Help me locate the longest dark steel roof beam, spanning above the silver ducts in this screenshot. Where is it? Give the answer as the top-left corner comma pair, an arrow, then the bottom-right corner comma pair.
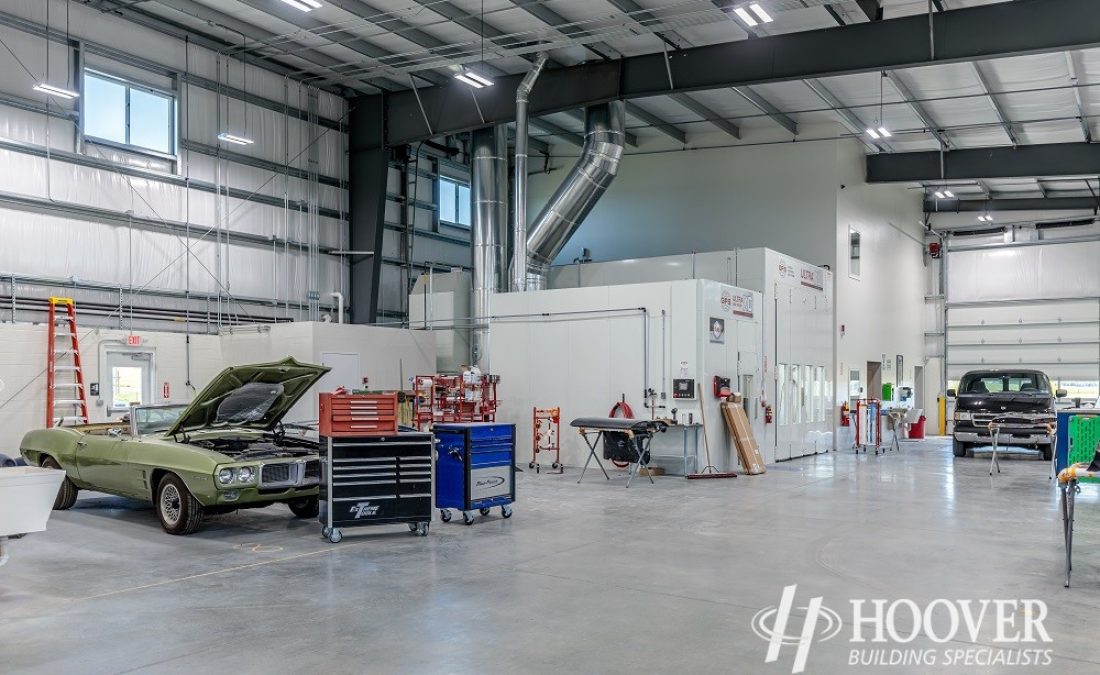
378,0 -> 1100,144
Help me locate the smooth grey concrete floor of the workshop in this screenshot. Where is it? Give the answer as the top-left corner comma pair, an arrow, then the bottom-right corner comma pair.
0,440 -> 1100,675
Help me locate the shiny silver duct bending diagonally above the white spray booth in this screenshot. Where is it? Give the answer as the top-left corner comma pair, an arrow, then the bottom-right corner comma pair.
525,101 -> 626,290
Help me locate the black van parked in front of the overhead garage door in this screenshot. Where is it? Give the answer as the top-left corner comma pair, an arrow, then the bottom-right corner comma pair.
947,369 -> 1066,461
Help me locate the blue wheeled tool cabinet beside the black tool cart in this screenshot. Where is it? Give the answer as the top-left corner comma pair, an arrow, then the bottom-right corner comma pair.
432,422 -> 516,525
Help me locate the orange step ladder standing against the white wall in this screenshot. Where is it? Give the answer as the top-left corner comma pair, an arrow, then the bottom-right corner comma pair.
46,297 -> 88,429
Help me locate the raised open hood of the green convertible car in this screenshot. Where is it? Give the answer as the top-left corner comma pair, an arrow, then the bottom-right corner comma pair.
165,357 -> 330,435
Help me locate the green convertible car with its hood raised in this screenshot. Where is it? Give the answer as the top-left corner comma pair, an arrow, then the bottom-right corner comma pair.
20,358 -> 329,534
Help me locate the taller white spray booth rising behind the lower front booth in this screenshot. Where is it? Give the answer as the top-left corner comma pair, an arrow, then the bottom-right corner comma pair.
549,248 -> 836,462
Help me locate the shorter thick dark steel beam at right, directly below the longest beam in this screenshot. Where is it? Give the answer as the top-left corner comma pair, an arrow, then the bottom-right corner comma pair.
867,143 -> 1100,182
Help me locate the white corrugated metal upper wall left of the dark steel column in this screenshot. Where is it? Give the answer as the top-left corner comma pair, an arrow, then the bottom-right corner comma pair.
0,0 -> 348,328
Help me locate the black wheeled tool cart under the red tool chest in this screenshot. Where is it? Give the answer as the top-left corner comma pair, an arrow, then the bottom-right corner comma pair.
319,432 -> 433,543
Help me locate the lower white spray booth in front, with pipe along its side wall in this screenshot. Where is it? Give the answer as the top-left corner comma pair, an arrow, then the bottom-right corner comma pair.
488,279 -> 762,472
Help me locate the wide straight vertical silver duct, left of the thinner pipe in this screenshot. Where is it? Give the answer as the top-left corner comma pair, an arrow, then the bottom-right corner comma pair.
470,124 -> 508,373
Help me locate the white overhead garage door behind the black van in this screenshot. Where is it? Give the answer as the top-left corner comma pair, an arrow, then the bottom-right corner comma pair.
946,237 -> 1100,400
